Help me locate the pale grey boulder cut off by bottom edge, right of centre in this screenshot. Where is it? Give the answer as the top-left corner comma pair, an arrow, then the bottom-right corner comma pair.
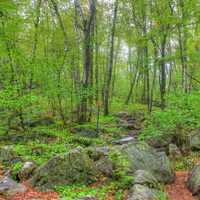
127,184 -> 158,200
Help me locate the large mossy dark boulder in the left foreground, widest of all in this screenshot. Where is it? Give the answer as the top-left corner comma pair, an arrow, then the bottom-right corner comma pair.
29,148 -> 99,190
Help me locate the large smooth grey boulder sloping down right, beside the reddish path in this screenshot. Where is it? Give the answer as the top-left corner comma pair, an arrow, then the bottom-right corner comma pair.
121,142 -> 175,183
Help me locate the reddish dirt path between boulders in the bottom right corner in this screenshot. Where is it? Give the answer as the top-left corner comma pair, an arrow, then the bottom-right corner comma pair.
166,172 -> 197,200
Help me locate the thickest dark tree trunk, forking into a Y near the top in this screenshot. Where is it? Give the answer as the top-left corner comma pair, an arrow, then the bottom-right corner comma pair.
75,0 -> 96,122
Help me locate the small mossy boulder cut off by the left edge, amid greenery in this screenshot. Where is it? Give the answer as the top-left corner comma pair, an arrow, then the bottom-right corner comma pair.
0,145 -> 20,163
